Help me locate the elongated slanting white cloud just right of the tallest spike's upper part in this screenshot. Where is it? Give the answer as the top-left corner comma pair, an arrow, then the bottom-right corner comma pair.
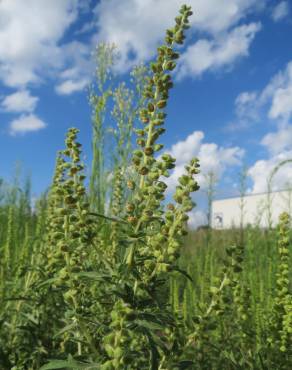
178,23 -> 261,77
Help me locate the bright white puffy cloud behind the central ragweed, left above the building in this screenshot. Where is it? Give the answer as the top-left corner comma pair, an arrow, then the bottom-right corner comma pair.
166,131 -> 244,191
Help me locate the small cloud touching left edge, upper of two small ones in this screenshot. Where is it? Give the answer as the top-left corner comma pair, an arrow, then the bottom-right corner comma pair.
1,90 -> 39,112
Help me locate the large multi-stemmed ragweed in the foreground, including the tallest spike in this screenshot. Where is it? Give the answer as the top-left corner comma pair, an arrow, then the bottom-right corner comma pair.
37,6 -> 198,369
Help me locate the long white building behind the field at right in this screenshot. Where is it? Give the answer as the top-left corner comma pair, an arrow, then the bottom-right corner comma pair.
212,190 -> 292,229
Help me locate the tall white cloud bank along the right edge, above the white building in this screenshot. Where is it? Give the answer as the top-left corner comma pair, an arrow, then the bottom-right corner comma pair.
234,61 -> 292,193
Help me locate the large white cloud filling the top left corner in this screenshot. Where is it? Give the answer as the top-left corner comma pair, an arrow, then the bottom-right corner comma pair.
0,0 -> 78,87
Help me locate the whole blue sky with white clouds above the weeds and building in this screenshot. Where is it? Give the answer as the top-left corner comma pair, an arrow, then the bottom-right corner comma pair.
0,0 -> 292,223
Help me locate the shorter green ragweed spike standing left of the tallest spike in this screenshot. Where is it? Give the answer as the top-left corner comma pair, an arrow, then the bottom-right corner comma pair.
45,129 -> 99,355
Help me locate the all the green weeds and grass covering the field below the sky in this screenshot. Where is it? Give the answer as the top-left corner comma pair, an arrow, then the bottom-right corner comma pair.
0,6 -> 292,370
